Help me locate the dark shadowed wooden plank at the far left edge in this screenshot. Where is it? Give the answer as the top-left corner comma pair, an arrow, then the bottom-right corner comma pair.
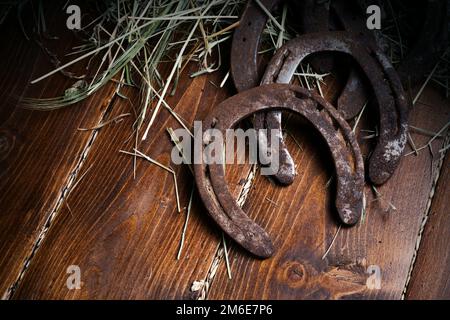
0,6 -> 118,298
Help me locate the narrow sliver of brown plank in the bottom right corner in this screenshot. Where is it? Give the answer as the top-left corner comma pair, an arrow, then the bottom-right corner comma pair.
406,153 -> 450,300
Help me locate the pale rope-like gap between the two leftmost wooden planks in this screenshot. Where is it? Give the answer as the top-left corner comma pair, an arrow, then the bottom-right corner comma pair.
2,89 -> 117,300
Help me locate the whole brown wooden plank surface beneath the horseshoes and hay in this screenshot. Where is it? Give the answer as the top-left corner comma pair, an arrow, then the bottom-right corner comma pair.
0,4 -> 450,299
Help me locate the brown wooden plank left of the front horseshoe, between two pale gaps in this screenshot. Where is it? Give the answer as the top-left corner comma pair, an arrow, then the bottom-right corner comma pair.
14,63 -> 255,299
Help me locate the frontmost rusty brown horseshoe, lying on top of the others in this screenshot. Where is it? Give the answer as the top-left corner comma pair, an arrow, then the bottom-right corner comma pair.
194,84 -> 364,258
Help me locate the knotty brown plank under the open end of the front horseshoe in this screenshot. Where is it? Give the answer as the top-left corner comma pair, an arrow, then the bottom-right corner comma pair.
208,89 -> 449,299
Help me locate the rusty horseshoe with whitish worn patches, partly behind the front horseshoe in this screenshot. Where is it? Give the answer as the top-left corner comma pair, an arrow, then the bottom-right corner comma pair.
255,31 -> 410,185
